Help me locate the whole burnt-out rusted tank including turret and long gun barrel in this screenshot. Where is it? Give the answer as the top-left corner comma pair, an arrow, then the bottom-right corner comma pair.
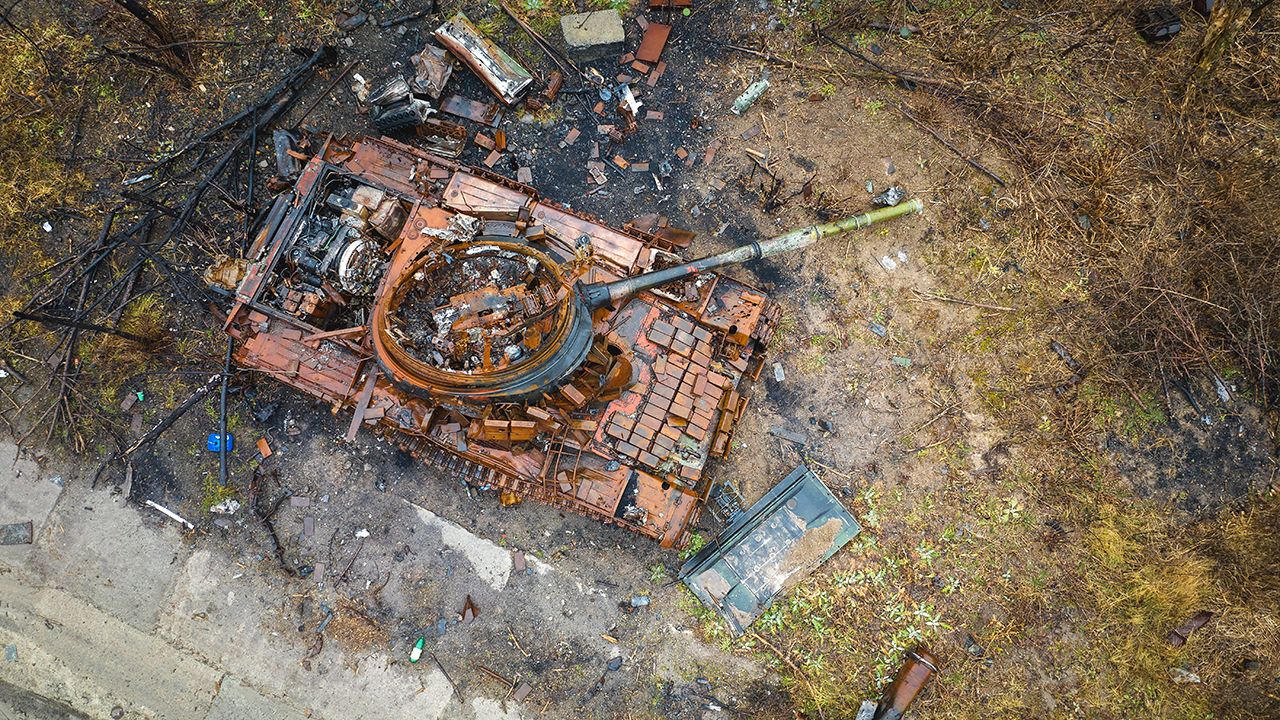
220,137 -> 922,547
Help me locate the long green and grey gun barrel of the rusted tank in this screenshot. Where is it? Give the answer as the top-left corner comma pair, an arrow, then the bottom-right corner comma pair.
581,199 -> 924,310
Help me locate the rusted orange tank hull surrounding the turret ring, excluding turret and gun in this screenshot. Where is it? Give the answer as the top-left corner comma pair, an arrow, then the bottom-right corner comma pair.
227,138 -> 778,547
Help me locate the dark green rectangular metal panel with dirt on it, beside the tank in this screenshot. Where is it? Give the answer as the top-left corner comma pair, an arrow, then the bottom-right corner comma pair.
680,465 -> 861,637
